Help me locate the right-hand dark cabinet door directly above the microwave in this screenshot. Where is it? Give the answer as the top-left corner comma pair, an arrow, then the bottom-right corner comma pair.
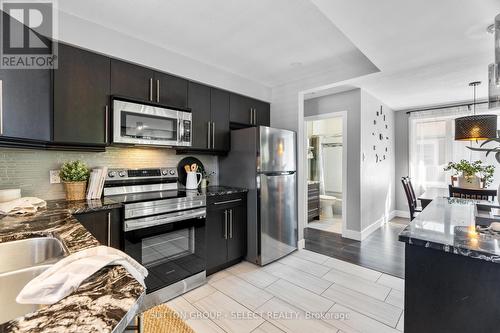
154,72 -> 188,108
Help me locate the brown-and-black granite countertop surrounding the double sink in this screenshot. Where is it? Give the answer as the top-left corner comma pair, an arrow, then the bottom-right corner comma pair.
0,199 -> 145,332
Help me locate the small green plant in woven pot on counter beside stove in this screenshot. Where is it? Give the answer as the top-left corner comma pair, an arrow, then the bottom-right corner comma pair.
59,160 -> 90,200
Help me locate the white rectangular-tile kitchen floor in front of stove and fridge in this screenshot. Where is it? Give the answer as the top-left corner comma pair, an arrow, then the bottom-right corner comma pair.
167,250 -> 404,333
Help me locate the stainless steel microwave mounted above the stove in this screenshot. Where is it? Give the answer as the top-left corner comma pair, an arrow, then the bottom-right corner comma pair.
113,98 -> 192,147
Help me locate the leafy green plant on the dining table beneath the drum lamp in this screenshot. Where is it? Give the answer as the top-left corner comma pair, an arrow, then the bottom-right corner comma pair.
444,160 -> 495,189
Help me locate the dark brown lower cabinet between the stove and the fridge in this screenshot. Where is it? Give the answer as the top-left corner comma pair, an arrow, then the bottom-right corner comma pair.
206,193 -> 247,275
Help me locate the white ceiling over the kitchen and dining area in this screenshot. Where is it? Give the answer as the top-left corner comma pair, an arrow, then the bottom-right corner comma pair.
59,0 -> 500,110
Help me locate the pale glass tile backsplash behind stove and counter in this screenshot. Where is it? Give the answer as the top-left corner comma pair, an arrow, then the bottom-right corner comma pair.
0,147 -> 219,199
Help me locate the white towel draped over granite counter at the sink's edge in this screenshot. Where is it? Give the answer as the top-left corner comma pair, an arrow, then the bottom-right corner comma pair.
16,246 -> 148,304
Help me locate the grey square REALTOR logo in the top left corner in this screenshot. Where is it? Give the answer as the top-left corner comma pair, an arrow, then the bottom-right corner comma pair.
0,0 -> 57,69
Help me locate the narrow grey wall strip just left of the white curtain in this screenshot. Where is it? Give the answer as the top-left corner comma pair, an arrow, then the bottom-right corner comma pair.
394,111 -> 410,211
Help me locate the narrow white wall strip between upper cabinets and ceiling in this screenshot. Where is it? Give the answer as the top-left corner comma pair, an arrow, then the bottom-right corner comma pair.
59,12 -> 271,101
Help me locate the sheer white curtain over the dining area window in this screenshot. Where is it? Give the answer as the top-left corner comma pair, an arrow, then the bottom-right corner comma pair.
409,104 -> 500,195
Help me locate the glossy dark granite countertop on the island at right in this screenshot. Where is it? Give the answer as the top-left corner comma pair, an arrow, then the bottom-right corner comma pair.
399,198 -> 500,263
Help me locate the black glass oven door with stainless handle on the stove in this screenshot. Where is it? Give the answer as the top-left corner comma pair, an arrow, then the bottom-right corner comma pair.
124,209 -> 206,294
